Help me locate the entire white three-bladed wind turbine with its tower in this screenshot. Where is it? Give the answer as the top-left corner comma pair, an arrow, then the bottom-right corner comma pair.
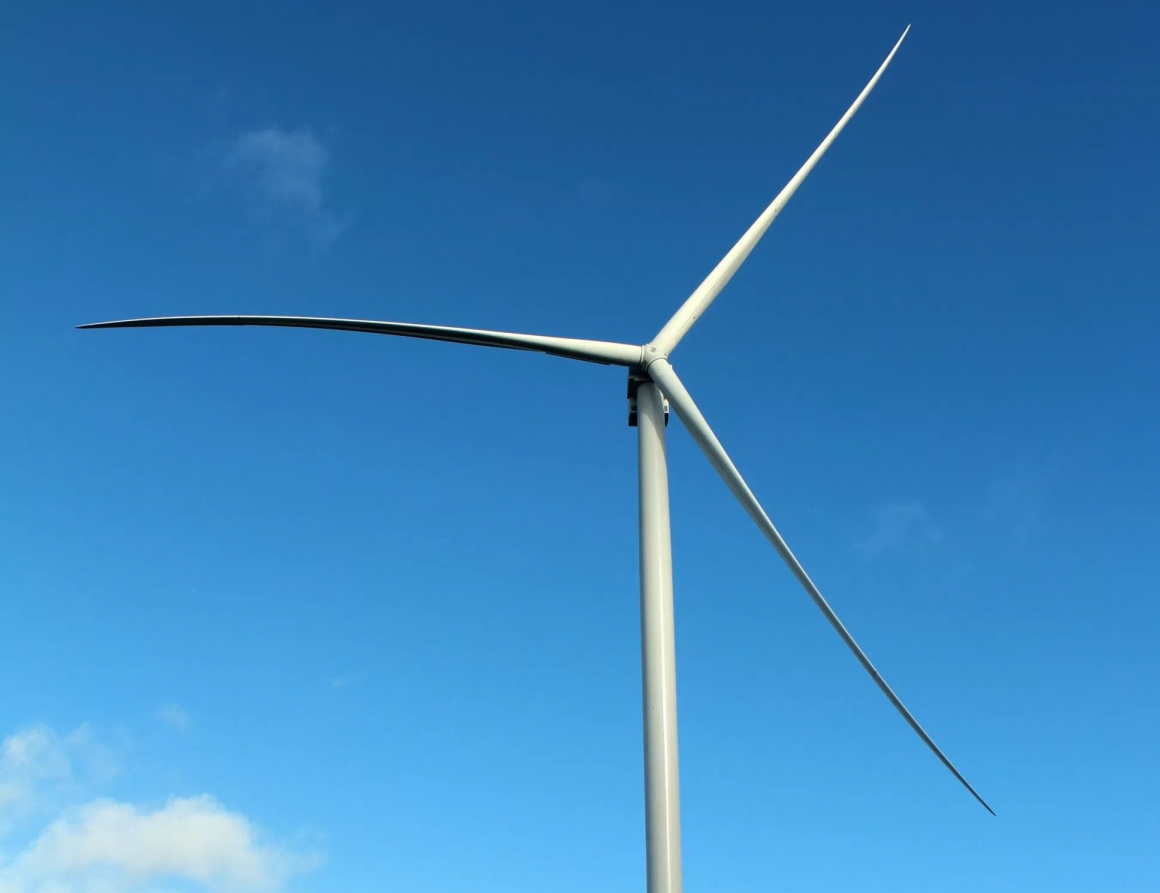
79,26 -> 994,893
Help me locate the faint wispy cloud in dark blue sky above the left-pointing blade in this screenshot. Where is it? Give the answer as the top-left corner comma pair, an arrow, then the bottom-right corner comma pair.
226,128 -> 342,244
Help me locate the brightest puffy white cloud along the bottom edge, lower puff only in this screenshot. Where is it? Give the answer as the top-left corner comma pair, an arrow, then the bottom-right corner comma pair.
0,796 -> 318,893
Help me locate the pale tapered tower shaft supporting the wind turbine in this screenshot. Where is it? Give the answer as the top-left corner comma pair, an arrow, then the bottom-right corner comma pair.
637,382 -> 681,893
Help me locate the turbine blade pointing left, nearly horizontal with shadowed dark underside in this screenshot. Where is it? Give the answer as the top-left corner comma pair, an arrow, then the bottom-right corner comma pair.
77,317 -> 640,366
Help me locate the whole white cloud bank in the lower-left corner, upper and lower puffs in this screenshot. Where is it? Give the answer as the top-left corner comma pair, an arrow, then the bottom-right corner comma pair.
0,726 -> 321,893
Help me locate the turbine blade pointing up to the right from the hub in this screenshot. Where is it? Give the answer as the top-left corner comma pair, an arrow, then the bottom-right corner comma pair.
652,26 -> 911,356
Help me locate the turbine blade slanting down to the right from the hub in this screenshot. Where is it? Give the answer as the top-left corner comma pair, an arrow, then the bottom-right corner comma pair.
648,360 -> 995,815
